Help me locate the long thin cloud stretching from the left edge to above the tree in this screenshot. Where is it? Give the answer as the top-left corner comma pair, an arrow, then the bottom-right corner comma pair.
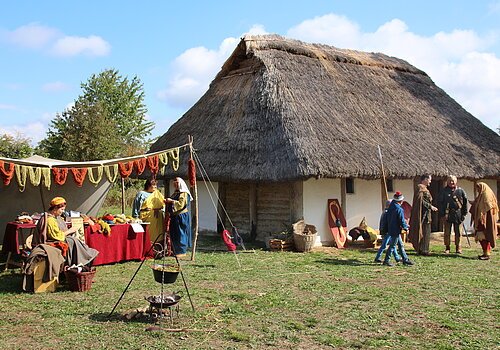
0,23 -> 111,57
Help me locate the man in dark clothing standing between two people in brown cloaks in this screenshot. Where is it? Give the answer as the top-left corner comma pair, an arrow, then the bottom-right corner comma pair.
438,175 -> 467,254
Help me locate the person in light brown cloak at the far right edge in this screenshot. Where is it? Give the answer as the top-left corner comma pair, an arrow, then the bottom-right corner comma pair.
470,182 -> 498,260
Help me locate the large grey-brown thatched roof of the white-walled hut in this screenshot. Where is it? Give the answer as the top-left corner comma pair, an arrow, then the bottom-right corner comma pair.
151,35 -> 500,181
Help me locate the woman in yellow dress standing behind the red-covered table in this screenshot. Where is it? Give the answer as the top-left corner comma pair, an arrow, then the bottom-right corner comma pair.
132,179 -> 165,242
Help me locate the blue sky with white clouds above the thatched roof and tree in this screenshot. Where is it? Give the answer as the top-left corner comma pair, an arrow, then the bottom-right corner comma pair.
0,0 -> 500,145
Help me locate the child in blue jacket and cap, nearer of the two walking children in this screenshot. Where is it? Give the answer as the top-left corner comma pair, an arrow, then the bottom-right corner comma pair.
377,191 -> 413,266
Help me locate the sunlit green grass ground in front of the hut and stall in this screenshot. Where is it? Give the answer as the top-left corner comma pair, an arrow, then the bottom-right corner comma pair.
0,235 -> 500,349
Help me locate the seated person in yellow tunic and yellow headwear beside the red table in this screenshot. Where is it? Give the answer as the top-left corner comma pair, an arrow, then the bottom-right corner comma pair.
46,197 -> 99,266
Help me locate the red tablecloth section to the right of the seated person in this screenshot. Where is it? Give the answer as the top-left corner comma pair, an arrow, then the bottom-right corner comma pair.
85,224 -> 152,265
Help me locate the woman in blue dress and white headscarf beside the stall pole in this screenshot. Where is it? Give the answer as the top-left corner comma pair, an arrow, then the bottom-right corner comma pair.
165,177 -> 192,257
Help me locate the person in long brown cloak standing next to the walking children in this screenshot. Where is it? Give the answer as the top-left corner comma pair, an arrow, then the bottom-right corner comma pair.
408,174 -> 438,255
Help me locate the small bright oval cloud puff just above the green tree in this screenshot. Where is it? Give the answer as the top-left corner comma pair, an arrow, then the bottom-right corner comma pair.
51,35 -> 111,57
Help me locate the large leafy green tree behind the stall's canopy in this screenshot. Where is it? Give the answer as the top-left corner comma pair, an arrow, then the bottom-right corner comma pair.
39,69 -> 154,161
